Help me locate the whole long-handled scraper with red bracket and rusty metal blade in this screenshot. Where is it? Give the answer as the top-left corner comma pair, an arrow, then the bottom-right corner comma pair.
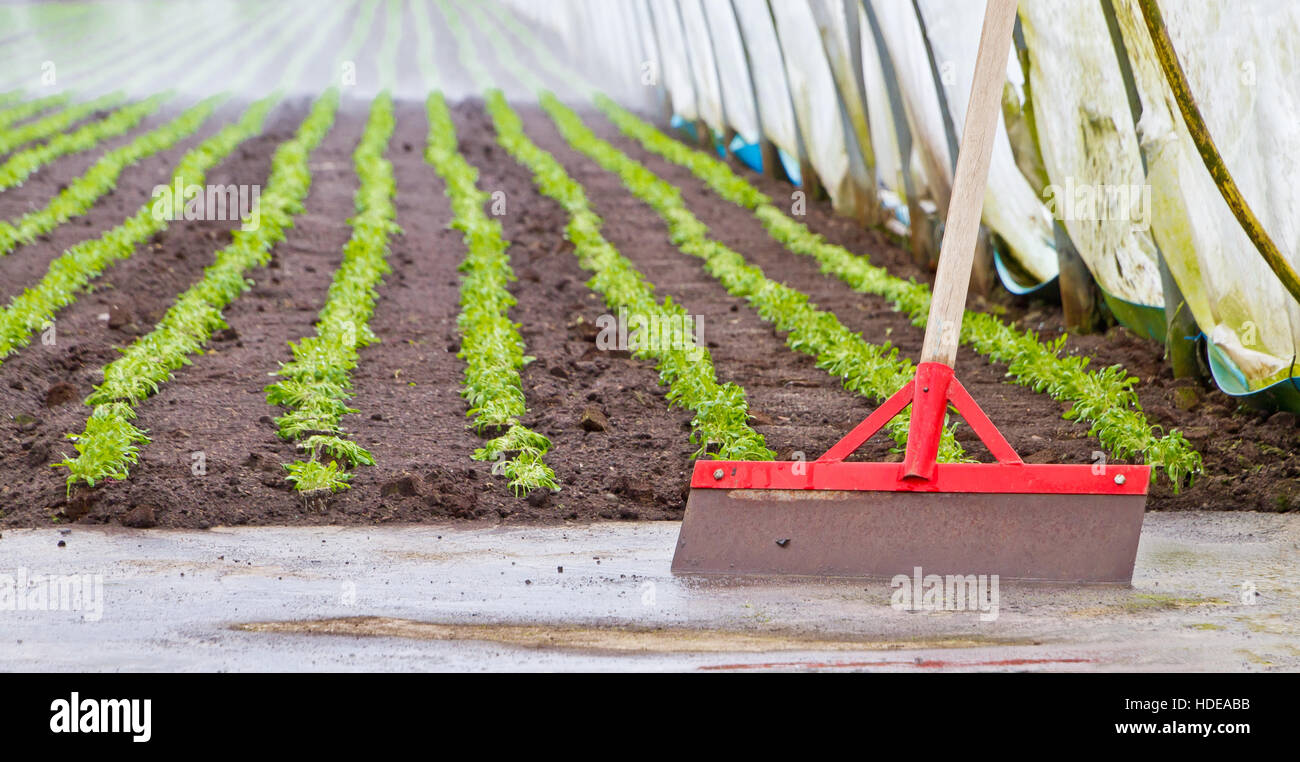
672,0 -> 1151,584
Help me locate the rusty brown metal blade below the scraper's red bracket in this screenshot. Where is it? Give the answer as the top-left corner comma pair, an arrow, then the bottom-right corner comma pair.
672,489 -> 1147,585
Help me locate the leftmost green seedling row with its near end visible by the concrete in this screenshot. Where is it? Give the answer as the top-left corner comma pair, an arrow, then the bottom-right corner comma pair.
55,90 -> 338,493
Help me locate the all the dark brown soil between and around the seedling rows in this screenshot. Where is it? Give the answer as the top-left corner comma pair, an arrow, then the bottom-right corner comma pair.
0,91 -> 1300,527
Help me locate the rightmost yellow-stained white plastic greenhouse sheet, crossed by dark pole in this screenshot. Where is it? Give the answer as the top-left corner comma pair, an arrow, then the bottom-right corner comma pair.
1117,0 -> 1300,390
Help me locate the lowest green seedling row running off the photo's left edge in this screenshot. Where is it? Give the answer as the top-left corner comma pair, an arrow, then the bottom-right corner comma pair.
0,95 -> 280,361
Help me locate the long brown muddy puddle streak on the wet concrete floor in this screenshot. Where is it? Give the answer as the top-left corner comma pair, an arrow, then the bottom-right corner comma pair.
234,616 -> 1039,653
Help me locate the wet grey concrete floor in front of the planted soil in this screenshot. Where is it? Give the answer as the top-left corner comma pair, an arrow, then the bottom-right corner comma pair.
0,512 -> 1300,671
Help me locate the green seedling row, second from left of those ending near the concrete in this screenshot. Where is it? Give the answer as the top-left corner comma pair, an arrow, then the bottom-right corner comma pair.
267,91 -> 400,497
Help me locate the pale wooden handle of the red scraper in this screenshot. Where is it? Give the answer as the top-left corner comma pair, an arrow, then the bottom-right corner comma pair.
913,0 -> 1015,368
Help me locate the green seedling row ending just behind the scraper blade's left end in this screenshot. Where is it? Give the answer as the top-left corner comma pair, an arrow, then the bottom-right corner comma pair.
486,90 -> 775,460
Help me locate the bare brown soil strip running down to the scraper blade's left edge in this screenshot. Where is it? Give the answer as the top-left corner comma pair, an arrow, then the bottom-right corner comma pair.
455,103 -> 696,519
